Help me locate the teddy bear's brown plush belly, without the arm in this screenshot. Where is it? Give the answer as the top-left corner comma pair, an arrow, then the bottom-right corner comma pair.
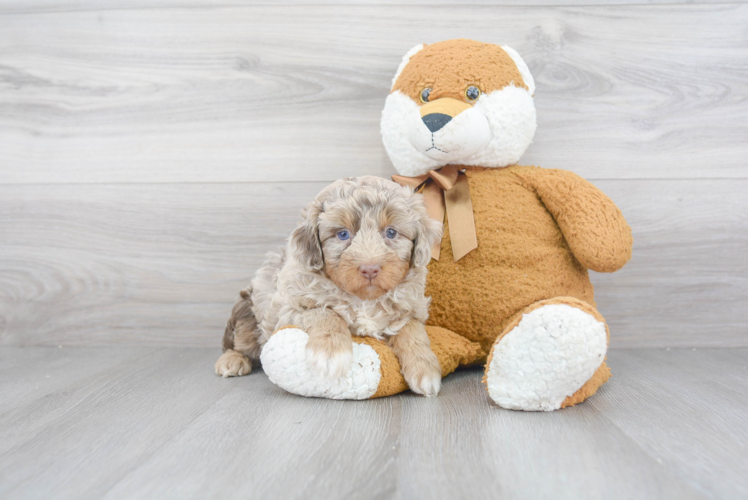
426,168 -> 594,352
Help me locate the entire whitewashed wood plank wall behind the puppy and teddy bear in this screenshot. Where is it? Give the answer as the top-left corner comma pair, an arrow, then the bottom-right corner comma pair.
0,0 -> 748,347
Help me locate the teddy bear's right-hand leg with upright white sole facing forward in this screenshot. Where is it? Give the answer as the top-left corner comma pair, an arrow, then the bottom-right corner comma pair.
483,297 -> 610,411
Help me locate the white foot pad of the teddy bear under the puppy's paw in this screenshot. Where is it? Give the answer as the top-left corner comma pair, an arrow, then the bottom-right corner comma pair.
260,328 -> 382,399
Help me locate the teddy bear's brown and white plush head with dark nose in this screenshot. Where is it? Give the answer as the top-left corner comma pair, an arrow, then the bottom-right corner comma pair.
381,39 -> 536,176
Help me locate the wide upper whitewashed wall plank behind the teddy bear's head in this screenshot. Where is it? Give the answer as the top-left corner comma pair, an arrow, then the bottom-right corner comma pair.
0,4 -> 748,184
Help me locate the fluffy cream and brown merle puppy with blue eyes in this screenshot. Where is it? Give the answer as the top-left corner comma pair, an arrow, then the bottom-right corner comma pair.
215,176 -> 442,396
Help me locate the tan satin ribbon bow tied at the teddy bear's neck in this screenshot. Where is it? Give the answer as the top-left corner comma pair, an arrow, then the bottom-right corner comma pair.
392,165 -> 478,262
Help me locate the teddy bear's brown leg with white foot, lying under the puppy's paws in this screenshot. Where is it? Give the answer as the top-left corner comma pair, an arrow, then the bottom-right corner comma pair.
260,326 -> 485,399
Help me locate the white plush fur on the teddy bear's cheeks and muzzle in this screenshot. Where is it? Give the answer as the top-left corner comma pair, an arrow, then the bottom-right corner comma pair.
381,81 -> 537,176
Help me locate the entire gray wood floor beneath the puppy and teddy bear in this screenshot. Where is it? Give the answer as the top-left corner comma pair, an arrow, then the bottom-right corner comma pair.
0,347 -> 748,499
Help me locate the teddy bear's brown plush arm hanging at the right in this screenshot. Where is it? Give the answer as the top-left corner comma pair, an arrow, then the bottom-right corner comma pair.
521,168 -> 633,273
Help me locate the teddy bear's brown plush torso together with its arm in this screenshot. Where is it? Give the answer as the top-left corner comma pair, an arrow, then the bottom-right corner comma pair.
426,166 -> 632,353
